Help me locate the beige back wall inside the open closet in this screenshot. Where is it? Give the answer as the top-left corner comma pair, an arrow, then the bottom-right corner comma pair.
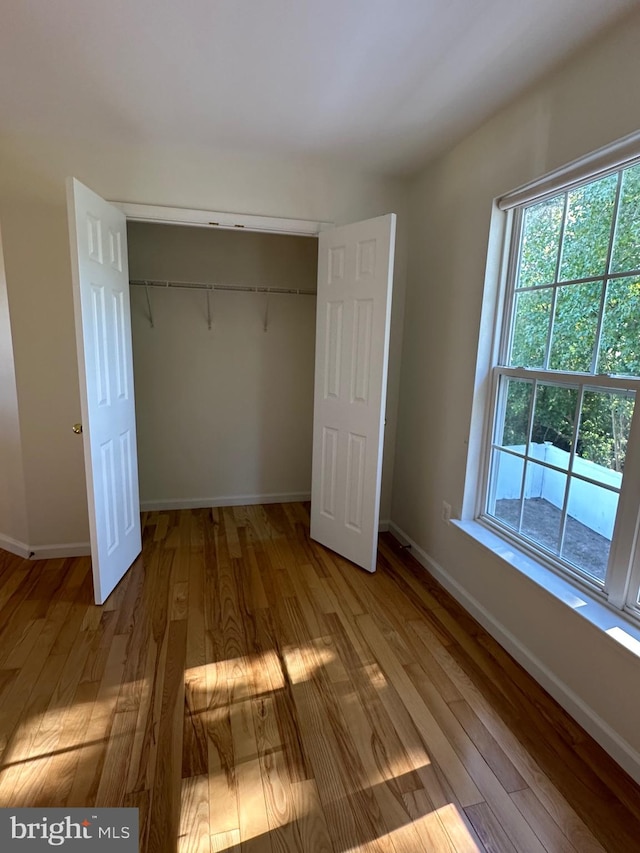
128,222 -> 318,508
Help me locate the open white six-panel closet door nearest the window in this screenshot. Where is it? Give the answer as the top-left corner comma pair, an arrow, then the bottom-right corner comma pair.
311,214 -> 396,572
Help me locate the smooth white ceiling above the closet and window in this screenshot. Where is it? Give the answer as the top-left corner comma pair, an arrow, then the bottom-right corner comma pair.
0,0 -> 639,172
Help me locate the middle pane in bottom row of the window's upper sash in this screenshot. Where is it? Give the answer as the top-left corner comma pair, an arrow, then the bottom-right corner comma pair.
549,282 -> 602,372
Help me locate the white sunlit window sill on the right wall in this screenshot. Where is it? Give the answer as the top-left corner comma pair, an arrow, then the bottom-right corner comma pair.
451,519 -> 640,659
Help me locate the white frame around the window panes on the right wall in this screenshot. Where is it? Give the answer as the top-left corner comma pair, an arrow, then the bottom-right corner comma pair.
476,133 -> 640,621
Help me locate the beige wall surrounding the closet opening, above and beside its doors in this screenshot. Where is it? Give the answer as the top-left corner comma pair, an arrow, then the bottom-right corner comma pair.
0,134 -> 406,548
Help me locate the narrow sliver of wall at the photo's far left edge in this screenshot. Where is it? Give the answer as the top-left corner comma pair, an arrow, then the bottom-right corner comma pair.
0,223 -> 28,556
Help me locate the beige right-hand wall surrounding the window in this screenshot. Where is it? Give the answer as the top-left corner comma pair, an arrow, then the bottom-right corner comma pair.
392,14 -> 640,778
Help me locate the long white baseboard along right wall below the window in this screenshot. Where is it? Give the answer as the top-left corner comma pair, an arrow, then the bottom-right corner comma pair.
389,521 -> 640,784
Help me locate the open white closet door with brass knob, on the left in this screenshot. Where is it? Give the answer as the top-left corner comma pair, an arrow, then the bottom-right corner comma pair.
67,178 -> 142,604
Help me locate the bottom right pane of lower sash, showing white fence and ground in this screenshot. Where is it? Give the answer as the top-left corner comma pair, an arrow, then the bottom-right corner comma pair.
562,476 -> 618,583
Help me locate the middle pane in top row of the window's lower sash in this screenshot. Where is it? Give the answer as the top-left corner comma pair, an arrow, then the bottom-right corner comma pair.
530,384 -> 578,470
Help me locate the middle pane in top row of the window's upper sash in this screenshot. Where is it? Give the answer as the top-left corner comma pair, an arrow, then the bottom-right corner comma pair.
560,175 -> 618,281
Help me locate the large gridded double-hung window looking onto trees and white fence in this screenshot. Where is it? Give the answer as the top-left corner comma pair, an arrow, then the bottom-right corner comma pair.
481,156 -> 640,615
